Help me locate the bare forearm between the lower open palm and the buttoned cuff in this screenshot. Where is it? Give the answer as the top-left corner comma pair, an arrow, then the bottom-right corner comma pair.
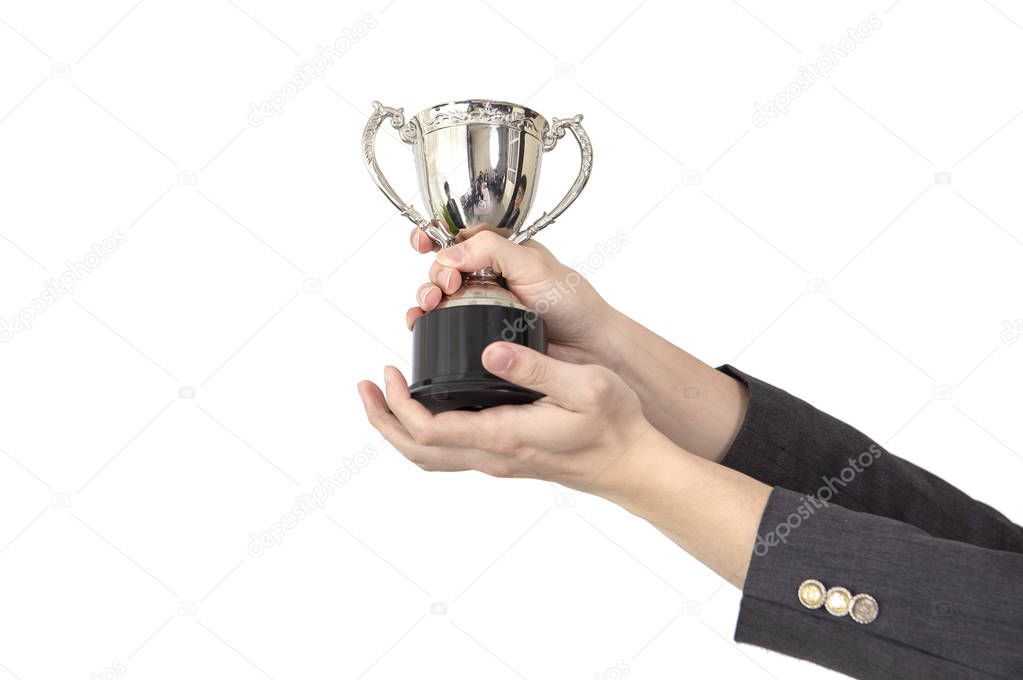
604,429 -> 771,588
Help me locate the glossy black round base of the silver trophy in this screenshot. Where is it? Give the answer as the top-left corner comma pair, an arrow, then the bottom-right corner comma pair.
409,304 -> 547,413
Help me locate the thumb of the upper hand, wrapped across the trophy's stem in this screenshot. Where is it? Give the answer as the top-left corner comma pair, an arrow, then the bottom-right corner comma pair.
437,231 -> 551,284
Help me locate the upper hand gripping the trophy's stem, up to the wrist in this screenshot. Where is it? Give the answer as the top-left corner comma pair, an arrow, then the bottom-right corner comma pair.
405,229 -> 616,365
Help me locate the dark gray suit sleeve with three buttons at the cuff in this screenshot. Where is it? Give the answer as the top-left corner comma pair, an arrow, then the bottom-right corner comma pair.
736,488 -> 1023,680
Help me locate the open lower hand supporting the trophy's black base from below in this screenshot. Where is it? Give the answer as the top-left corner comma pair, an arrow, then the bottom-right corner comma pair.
358,341 -> 663,498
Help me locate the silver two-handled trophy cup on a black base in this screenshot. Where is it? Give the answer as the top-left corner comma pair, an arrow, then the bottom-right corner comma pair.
362,99 -> 593,413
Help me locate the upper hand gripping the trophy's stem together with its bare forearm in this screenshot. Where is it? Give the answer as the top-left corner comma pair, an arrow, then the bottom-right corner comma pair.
405,228 -> 749,461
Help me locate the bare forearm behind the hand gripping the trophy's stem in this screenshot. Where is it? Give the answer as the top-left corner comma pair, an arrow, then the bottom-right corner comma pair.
599,311 -> 748,461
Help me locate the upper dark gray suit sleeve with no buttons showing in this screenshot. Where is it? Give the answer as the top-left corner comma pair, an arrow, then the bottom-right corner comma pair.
720,366 -> 1023,552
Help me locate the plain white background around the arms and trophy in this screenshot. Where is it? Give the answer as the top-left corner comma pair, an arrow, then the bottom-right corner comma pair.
0,0 -> 1023,680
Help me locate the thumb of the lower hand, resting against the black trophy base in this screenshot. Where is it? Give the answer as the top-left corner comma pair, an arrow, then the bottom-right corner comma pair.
483,343 -> 580,408
